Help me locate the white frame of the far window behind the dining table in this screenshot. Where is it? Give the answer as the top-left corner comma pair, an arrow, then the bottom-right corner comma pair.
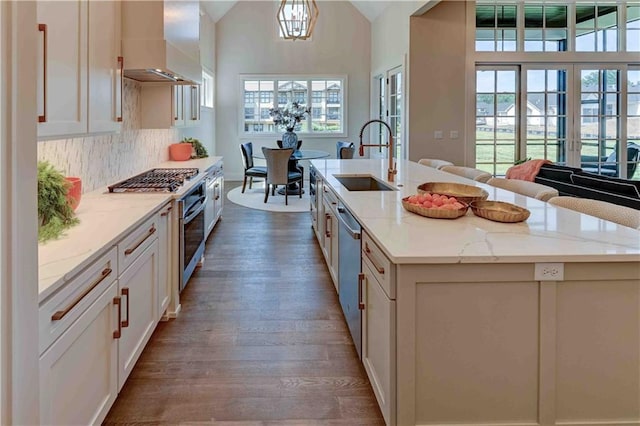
237,74 -> 348,139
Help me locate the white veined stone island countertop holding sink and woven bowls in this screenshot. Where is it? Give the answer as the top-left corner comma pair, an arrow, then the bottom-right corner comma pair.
312,159 -> 640,264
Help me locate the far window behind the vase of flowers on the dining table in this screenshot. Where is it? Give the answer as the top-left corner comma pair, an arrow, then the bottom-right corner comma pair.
241,77 -> 345,135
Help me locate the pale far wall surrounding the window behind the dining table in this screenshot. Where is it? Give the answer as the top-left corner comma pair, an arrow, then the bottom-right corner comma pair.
215,1 -> 371,180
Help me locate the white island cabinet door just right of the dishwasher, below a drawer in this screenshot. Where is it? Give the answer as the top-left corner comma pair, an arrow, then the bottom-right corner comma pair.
359,256 -> 396,425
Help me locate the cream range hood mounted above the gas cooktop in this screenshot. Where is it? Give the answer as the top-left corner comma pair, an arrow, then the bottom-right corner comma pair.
122,0 -> 202,84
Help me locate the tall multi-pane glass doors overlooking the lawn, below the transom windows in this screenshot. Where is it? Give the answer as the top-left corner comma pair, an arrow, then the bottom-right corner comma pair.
476,64 -> 640,179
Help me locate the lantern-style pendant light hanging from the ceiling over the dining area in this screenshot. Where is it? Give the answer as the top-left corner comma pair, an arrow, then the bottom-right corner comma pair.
276,0 -> 319,40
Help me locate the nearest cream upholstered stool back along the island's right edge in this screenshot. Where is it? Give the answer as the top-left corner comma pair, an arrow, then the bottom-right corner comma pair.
549,196 -> 640,229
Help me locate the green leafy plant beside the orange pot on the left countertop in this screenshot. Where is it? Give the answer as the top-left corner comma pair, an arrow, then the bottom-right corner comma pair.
38,161 -> 79,242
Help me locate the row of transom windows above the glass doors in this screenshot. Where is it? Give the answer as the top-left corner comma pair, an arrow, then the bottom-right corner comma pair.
475,0 -> 640,52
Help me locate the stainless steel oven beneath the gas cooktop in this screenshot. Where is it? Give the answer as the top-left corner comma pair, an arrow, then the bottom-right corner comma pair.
178,181 -> 207,291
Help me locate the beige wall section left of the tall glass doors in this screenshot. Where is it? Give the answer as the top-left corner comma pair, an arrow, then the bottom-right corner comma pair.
408,1 -> 467,165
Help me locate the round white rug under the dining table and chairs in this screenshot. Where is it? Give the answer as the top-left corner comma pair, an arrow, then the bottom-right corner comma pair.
227,182 -> 310,213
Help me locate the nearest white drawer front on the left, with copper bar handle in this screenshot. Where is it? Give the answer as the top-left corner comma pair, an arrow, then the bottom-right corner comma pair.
38,247 -> 118,354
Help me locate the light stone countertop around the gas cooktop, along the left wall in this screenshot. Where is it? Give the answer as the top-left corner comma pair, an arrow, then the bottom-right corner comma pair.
38,157 -> 222,302
